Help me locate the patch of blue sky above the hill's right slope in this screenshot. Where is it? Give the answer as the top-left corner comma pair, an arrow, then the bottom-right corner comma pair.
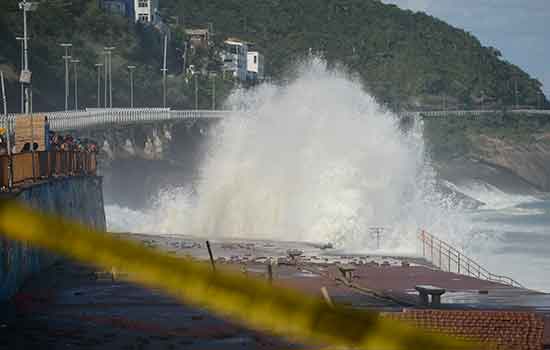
382,0 -> 550,96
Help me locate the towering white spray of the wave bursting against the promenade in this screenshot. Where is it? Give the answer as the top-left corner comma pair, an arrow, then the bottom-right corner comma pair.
111,60 -> 469,252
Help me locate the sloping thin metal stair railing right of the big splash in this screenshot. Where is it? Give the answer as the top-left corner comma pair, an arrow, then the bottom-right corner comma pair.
418,230 -> 523,288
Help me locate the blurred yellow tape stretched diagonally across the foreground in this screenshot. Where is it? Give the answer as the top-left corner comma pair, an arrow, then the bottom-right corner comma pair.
0,201 -> 473,350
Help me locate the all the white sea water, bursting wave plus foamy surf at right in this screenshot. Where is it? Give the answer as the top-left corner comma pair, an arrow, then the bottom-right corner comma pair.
106,59 -> 550,290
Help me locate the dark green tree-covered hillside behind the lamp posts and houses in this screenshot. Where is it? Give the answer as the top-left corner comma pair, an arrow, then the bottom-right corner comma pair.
0,0 -> 548,110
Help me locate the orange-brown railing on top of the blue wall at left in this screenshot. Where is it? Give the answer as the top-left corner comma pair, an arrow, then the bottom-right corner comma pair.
0,151 -> 97,188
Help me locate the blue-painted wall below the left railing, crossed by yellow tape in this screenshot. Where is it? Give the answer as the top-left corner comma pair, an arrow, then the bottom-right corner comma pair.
0,177 -> 105,301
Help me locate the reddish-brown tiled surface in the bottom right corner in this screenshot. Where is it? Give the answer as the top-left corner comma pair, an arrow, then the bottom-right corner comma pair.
383,309 -> 544,350
